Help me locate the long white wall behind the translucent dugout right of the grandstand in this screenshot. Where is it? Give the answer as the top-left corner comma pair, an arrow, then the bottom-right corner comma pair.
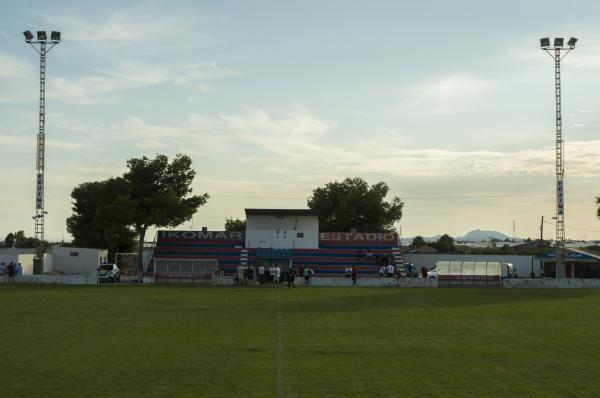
405,253 -> 541,278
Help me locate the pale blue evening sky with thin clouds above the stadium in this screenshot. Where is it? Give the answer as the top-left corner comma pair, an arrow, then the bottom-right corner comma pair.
0,0 -> 600,240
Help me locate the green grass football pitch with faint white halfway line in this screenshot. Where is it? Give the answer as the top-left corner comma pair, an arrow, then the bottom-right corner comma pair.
0,284 -> 600,398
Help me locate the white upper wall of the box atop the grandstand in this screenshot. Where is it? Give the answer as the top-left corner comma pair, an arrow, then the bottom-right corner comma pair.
246,215 -> 319,249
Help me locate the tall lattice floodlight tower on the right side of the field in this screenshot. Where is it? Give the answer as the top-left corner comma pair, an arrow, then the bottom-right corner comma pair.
540,37 -> 577,278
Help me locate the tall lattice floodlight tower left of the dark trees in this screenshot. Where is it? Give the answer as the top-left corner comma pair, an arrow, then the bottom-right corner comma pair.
23,30 -> 60,274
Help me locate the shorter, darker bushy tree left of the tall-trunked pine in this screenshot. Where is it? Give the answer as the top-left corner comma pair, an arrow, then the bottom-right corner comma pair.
67,177 -> 136,261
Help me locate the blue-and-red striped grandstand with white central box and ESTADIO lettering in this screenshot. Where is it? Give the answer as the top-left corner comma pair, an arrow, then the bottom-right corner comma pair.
146,209 -> 403,277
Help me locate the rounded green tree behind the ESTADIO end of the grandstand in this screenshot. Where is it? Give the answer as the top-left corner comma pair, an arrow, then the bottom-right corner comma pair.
308,177 -> 404,232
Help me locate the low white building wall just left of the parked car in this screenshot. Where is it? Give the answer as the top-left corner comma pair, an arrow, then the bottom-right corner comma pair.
51,247 -> 107,275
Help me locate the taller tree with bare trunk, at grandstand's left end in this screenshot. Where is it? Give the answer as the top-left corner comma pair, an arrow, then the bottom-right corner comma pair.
123,155 -> 208,272
